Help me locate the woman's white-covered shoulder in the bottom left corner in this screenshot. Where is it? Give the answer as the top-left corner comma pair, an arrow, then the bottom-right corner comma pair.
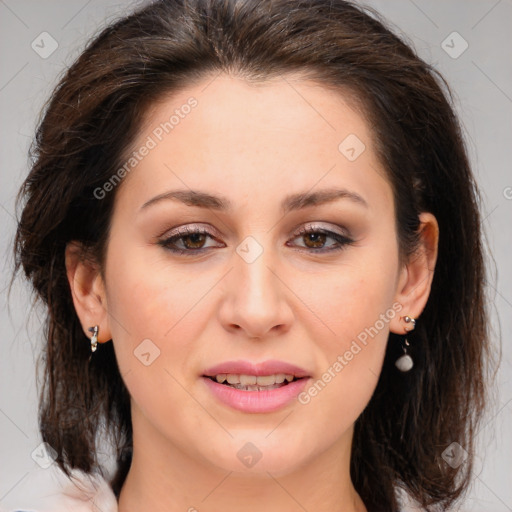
1,468 -> 118,512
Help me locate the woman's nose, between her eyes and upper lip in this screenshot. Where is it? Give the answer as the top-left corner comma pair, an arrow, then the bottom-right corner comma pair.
219,237 -> 294,339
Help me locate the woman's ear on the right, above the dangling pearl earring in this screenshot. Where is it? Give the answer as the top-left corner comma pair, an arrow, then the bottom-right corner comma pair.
390,212 -> 439,334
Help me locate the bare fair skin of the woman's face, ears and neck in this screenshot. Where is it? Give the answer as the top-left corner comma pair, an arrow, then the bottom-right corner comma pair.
66,75 -> 438,512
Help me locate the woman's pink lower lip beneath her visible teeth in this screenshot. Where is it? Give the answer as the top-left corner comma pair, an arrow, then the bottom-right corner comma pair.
203,377 -> 309,413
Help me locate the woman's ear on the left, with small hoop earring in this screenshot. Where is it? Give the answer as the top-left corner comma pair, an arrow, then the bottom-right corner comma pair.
65,242 -> 112,343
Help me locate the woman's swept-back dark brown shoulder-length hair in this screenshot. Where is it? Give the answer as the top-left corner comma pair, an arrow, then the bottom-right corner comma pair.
15,0 -> 489,512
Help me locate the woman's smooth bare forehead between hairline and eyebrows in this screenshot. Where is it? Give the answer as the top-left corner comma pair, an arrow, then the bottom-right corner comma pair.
114,75 -> 390,213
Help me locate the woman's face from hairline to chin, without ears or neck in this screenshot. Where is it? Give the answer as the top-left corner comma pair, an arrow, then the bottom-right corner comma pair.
96,75 -> 411,475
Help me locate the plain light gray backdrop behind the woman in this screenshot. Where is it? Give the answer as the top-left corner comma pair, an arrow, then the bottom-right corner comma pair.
0,0 -> 512,512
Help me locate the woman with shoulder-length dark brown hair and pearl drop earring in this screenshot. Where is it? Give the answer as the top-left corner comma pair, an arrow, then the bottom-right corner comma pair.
16,0 -> 488,512
